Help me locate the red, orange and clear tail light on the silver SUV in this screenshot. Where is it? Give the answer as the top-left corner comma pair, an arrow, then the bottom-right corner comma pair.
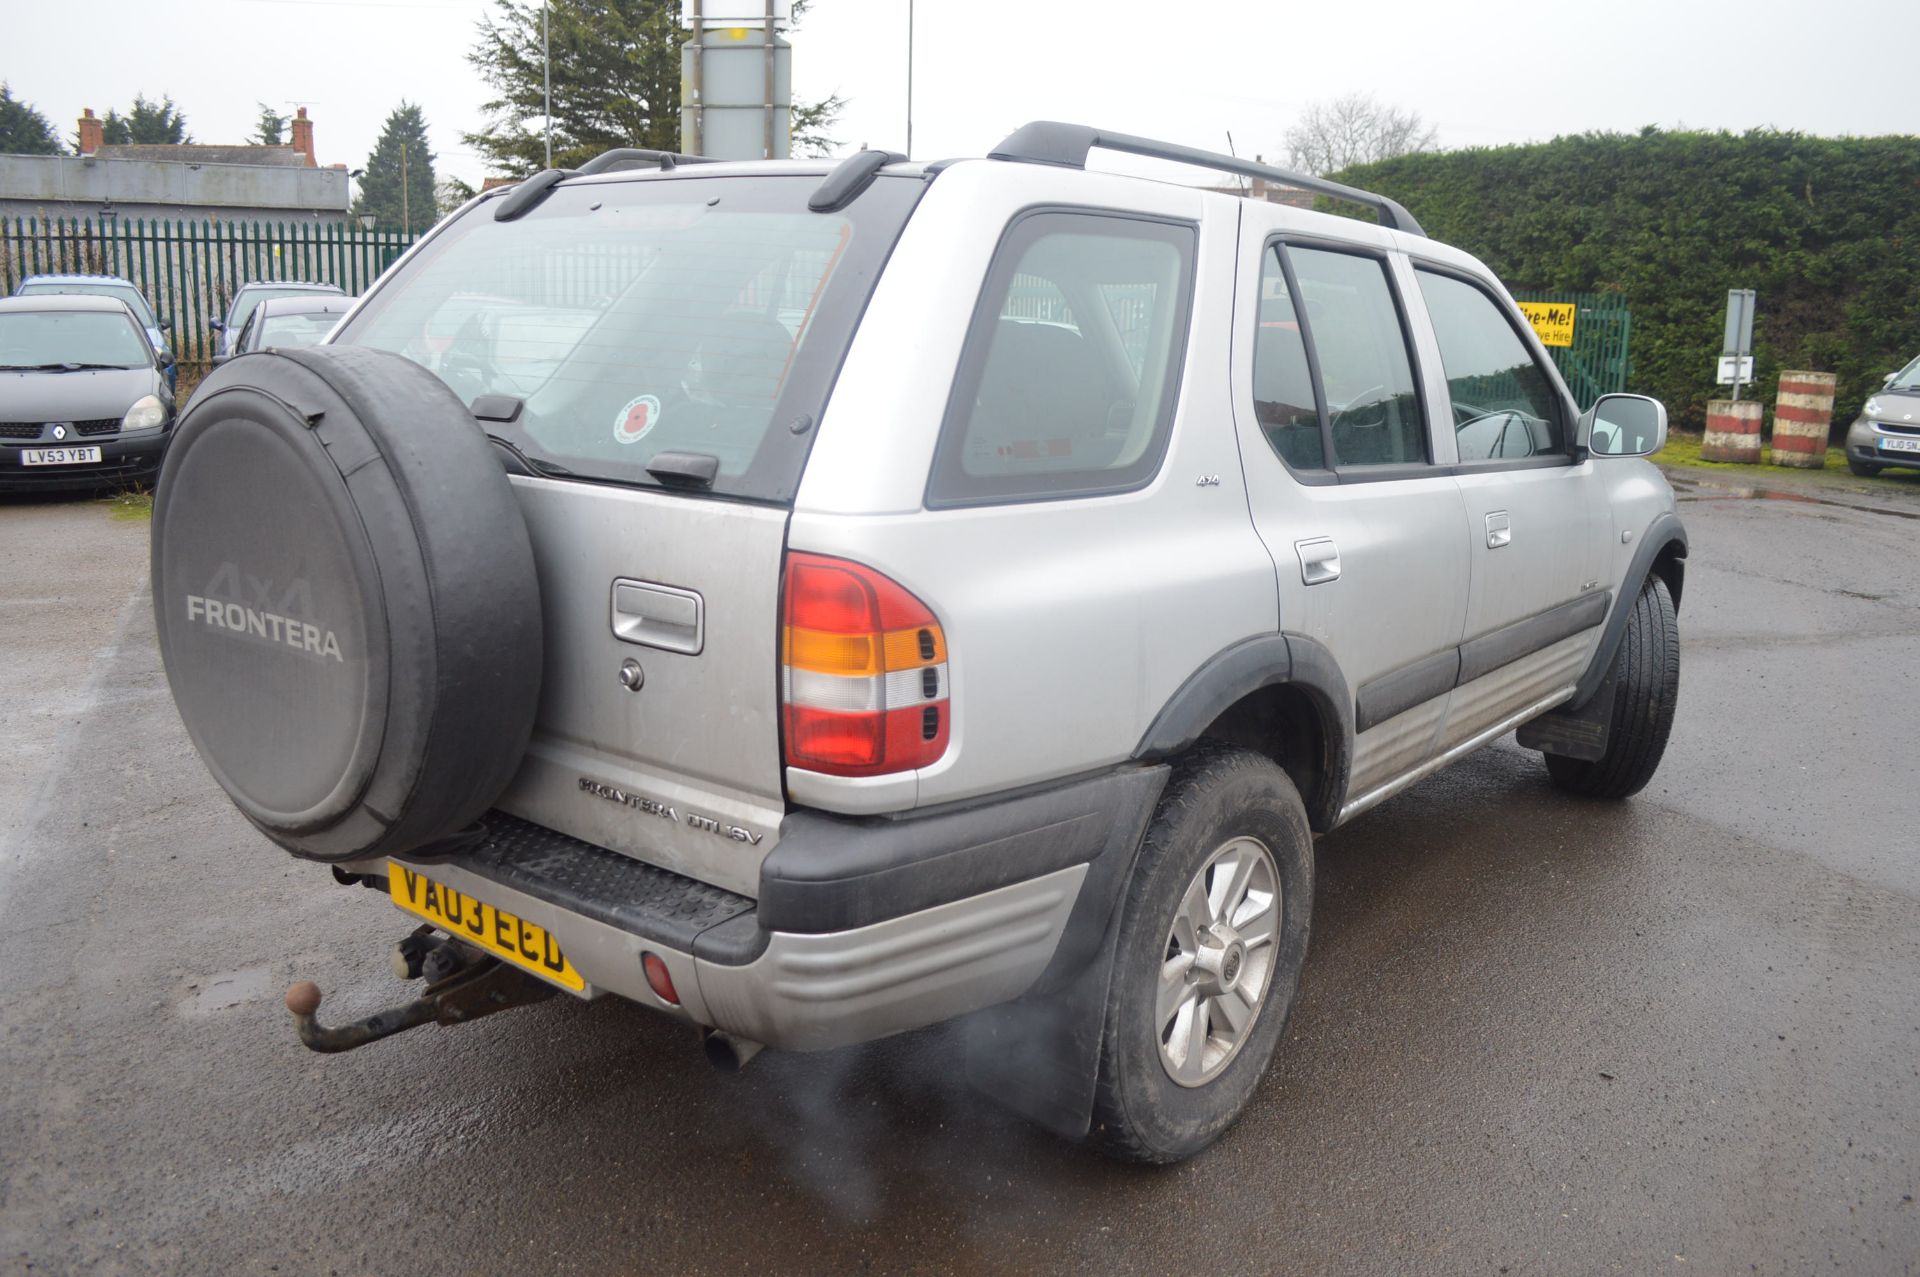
781,553 -> 950,776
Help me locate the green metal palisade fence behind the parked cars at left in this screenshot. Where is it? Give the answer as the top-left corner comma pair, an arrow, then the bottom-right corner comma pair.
0,217 -> 420,367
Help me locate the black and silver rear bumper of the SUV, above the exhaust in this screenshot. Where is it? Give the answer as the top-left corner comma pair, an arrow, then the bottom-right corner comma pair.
351,768 -> 1165,1050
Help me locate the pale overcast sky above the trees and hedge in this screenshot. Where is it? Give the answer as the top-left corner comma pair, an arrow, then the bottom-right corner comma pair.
0,0 -> 1920,192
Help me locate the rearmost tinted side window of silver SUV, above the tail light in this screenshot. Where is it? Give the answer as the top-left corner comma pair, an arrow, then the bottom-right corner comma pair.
927,211 -> 1194,505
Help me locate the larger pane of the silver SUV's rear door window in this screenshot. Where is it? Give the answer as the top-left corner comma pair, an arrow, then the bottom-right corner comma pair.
1286,246 -> 1428,467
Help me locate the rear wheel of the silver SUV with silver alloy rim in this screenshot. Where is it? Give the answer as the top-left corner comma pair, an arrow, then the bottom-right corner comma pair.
1089,745 -> 1313,1162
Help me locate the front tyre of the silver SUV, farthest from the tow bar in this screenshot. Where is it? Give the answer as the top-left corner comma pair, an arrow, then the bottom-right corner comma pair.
1546,576 -> 1680,799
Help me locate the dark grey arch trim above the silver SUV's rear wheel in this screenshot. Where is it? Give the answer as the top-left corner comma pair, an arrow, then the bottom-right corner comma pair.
1133,632 -> 1354,833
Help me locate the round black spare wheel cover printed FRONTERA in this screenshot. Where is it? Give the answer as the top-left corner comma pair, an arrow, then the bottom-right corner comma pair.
152,346 -> 541,860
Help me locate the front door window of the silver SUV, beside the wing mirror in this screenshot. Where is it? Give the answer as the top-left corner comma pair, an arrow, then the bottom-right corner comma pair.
1417,271 -> 1565,463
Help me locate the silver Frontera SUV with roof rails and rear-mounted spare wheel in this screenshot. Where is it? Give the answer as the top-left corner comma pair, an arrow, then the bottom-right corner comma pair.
154,123 -> 1686,1162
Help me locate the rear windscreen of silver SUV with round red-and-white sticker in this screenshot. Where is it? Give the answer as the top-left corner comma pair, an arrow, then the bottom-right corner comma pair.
334,175 -> 922,501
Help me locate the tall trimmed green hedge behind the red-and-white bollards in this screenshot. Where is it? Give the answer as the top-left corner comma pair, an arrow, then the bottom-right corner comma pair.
1338,129 -> 1920,430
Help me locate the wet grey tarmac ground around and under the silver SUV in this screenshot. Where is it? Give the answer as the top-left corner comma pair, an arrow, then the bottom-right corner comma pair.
0,480 -> 1920,1273
